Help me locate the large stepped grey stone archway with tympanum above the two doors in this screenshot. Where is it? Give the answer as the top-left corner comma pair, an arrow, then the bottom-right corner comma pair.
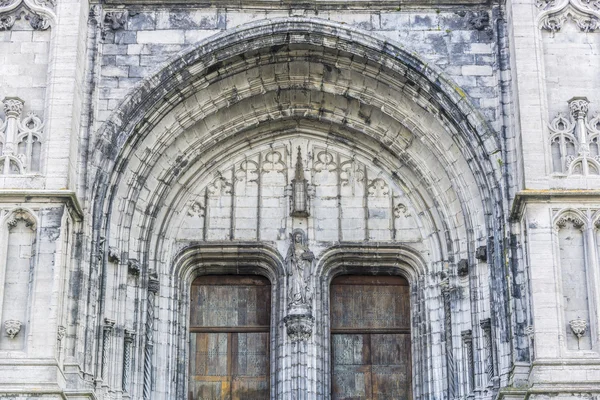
87,18 -> 510,398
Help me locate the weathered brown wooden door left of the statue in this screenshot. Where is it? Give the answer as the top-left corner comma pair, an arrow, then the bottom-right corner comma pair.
188,275 -> 271,400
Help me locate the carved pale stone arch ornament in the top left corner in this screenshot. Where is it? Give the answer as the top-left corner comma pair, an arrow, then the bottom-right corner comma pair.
0,0 -> 56,30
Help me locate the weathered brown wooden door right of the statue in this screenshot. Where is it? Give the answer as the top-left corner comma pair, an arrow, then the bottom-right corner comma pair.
331,275 -> 412,400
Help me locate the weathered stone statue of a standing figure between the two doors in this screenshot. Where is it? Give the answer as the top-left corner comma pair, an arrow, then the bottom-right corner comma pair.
285,229 -> 315,309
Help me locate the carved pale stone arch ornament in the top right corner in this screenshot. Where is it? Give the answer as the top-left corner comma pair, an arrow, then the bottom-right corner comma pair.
536,0 -> 600,33
